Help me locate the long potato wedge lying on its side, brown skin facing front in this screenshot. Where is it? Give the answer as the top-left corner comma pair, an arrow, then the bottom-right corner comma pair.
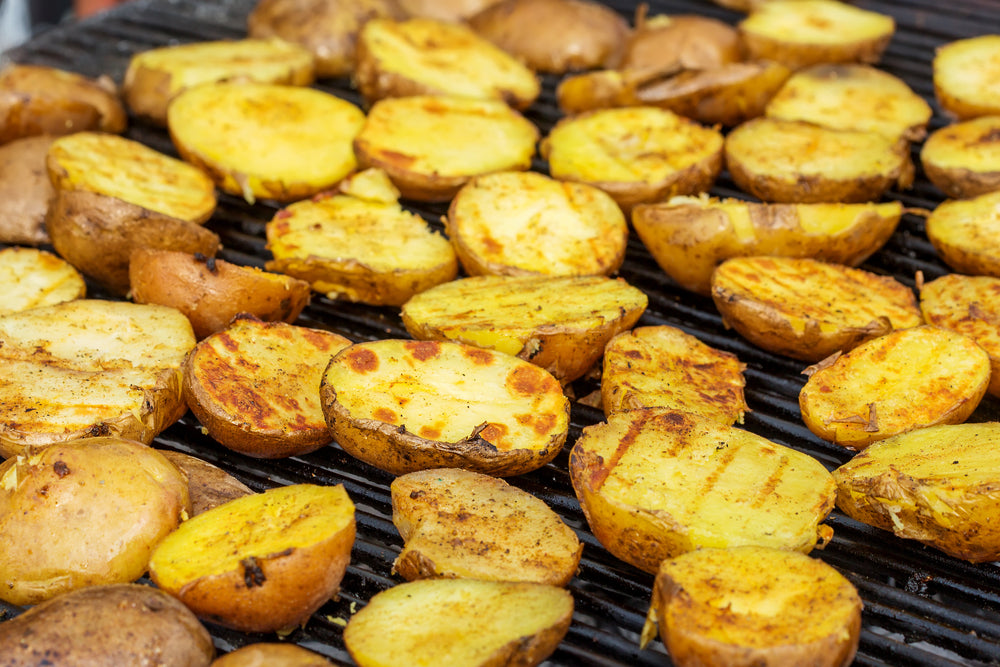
632,197 -> 903,295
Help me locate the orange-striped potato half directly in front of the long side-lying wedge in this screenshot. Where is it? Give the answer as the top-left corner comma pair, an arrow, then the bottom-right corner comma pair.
712,257 -> 923,361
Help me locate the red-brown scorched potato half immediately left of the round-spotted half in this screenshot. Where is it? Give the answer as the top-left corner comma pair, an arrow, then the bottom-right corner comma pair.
183,317 -> 351,458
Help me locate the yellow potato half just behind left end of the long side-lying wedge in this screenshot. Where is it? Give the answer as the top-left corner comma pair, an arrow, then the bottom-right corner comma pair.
541,107 -> 723,213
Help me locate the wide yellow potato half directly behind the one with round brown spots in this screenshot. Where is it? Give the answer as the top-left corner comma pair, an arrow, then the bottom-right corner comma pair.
402,276 -> 648,384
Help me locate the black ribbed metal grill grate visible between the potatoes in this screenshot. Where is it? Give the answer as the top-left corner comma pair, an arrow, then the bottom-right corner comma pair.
2,0 -> 1000,667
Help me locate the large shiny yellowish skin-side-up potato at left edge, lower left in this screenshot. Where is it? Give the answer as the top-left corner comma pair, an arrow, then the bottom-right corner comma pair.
0,438 -> 191,605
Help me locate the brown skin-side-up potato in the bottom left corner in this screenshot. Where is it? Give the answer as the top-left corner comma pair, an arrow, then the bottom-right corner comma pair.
0,584 -> 215,667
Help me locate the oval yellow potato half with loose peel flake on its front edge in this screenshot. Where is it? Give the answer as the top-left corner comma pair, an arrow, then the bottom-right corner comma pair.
799,326 -> 990,449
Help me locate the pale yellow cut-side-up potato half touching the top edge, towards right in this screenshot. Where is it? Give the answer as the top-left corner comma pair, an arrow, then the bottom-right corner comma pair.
738,0 -> 896,69
